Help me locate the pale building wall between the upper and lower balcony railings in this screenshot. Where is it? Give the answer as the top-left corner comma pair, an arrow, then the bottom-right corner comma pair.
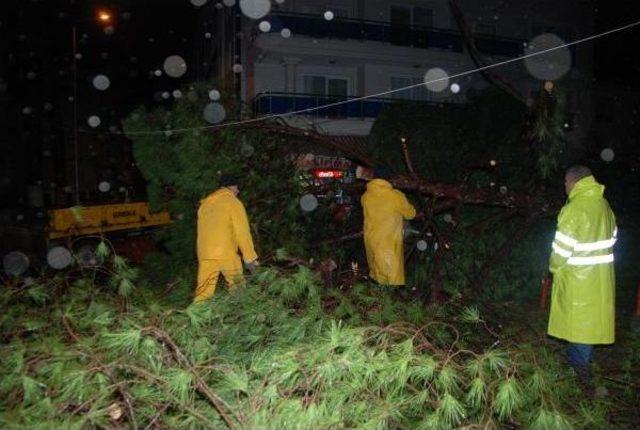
255,35 -> 516,98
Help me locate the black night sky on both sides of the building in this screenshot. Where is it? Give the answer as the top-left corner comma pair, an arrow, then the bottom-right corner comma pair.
0,0 -> 640,208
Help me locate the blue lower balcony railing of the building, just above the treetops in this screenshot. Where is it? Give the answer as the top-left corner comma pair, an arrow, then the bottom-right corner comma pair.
253,92 -> 446,119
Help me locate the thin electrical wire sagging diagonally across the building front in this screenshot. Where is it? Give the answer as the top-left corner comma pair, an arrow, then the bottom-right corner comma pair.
121,20 -> 640,136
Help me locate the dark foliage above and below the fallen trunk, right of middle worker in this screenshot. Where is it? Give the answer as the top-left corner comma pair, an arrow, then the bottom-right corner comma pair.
370,89 -> 566,300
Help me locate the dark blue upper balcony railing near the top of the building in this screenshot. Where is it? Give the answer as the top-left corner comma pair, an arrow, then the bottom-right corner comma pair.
262,13 -> 524,56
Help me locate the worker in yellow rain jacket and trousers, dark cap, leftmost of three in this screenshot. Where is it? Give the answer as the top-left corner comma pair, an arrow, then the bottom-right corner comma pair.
194,175 -> 258,302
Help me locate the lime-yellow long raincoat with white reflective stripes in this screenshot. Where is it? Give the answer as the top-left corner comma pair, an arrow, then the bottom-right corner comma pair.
548,176 -> 617,344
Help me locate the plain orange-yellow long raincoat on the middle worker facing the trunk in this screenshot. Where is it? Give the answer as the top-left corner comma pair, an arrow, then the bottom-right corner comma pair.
361,179 -> 416,285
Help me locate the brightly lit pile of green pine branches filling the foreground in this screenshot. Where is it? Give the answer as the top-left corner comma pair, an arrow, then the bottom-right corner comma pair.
0,250 -> 624,429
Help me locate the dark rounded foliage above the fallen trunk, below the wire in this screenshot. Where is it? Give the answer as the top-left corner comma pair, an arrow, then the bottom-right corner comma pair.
370,91 -> 535,185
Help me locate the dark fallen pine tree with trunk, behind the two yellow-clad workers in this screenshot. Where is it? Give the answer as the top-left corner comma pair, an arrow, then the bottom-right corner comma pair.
124,83 -> 576,301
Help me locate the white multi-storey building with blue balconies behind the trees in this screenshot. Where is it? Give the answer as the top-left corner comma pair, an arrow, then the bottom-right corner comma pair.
209,0 -> 594,136
